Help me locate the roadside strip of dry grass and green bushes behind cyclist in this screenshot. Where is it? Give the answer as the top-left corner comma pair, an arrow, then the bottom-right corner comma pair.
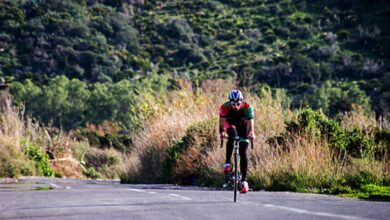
0,81 -> 390,200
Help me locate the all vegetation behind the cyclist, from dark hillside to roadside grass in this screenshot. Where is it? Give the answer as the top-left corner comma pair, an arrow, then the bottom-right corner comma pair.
0,0 -> 390,200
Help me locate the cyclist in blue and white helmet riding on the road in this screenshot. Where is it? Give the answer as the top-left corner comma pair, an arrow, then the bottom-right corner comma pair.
219,89 -> 255,193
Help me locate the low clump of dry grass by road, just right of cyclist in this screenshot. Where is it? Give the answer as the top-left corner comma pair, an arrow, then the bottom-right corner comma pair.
250,136 -> 340,191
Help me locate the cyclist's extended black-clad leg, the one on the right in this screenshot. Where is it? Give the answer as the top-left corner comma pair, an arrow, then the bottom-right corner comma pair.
237,124 -> 249,181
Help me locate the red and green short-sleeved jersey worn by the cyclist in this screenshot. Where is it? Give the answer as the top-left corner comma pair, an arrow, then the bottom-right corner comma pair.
219,102 -> 254,124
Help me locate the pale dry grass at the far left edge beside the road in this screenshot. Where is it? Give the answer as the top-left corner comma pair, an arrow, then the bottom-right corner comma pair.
0,99 -> 82,177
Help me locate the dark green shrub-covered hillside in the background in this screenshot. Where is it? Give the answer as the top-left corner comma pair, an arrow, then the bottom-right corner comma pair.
0,0 -> 390,127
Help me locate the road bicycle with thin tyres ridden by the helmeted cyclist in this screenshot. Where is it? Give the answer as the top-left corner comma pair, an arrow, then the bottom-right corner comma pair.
221,136 -> 253,202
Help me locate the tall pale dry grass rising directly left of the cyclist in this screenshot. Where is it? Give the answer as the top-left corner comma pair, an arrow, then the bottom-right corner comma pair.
125,80 -> 233,182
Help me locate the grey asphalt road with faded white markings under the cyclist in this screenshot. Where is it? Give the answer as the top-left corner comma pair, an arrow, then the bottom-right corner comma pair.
0,177 -> 390,220
